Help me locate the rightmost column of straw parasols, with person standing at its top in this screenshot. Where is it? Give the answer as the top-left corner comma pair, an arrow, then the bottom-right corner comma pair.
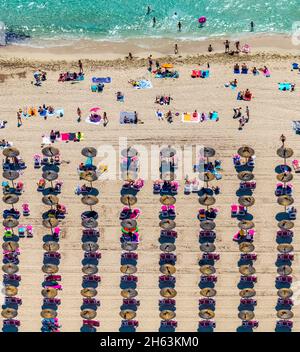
275,135 -> 296,332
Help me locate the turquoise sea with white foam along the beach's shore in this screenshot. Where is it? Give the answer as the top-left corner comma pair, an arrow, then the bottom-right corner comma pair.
0,0 -> 300,45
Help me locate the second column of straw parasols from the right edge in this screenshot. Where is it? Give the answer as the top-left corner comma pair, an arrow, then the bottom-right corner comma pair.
231,146 -> 259,331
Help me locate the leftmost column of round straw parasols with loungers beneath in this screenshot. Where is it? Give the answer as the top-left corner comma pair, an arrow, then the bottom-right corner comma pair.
1,147 -> 24,332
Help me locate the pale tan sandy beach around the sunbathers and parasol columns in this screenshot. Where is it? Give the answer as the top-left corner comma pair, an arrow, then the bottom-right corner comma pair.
0,36 -> 300,332
